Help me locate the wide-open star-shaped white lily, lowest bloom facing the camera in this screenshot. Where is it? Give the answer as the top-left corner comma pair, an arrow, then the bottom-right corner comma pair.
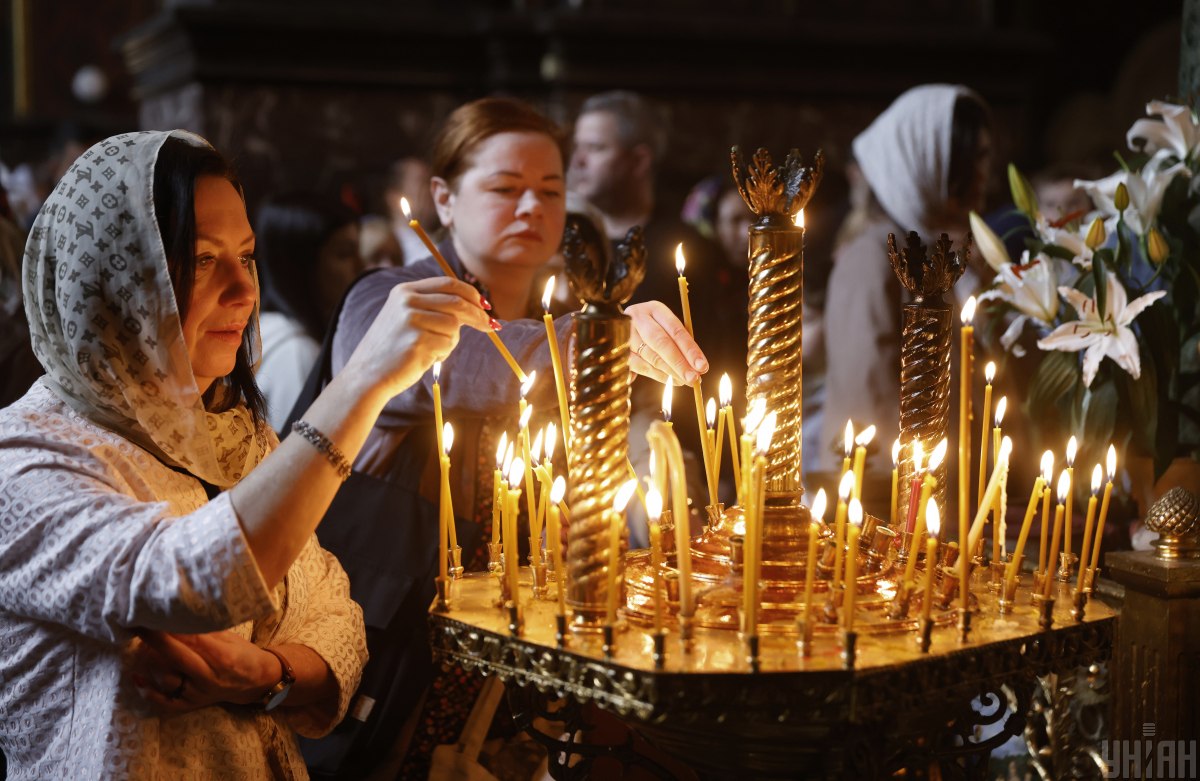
1038,274 -> 1166,388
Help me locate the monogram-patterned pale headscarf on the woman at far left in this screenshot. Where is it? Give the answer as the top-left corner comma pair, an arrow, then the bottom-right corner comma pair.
23,131 -> 274,488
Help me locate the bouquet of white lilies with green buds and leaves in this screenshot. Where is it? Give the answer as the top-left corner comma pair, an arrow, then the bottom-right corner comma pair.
971,102 -> 1200,476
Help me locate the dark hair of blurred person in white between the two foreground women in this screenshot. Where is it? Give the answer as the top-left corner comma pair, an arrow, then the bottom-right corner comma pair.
254,193 -> 358,342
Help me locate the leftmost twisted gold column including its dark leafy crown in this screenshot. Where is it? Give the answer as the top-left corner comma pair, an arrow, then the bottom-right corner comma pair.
563,218 -> 646,631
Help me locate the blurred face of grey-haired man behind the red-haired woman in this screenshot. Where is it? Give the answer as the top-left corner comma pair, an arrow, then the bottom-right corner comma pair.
566,112 -> 643,211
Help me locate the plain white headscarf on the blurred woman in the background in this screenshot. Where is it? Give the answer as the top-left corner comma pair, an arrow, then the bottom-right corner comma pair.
853,84 -> 983,236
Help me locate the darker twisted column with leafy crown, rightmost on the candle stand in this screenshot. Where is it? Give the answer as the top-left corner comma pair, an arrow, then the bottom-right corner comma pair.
888,233 -> 971,518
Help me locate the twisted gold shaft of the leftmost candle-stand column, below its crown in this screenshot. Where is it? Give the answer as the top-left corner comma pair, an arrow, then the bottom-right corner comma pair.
566,307 -> 630,626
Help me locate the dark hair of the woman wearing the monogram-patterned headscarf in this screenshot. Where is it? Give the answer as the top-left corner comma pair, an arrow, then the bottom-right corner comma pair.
154,137 -> 266,421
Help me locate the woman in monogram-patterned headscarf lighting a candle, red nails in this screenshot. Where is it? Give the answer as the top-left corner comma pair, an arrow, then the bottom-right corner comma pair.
0,131 -> 487,779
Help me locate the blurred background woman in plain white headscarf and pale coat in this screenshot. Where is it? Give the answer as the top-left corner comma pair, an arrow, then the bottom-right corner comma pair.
816,84 -> 991,470
